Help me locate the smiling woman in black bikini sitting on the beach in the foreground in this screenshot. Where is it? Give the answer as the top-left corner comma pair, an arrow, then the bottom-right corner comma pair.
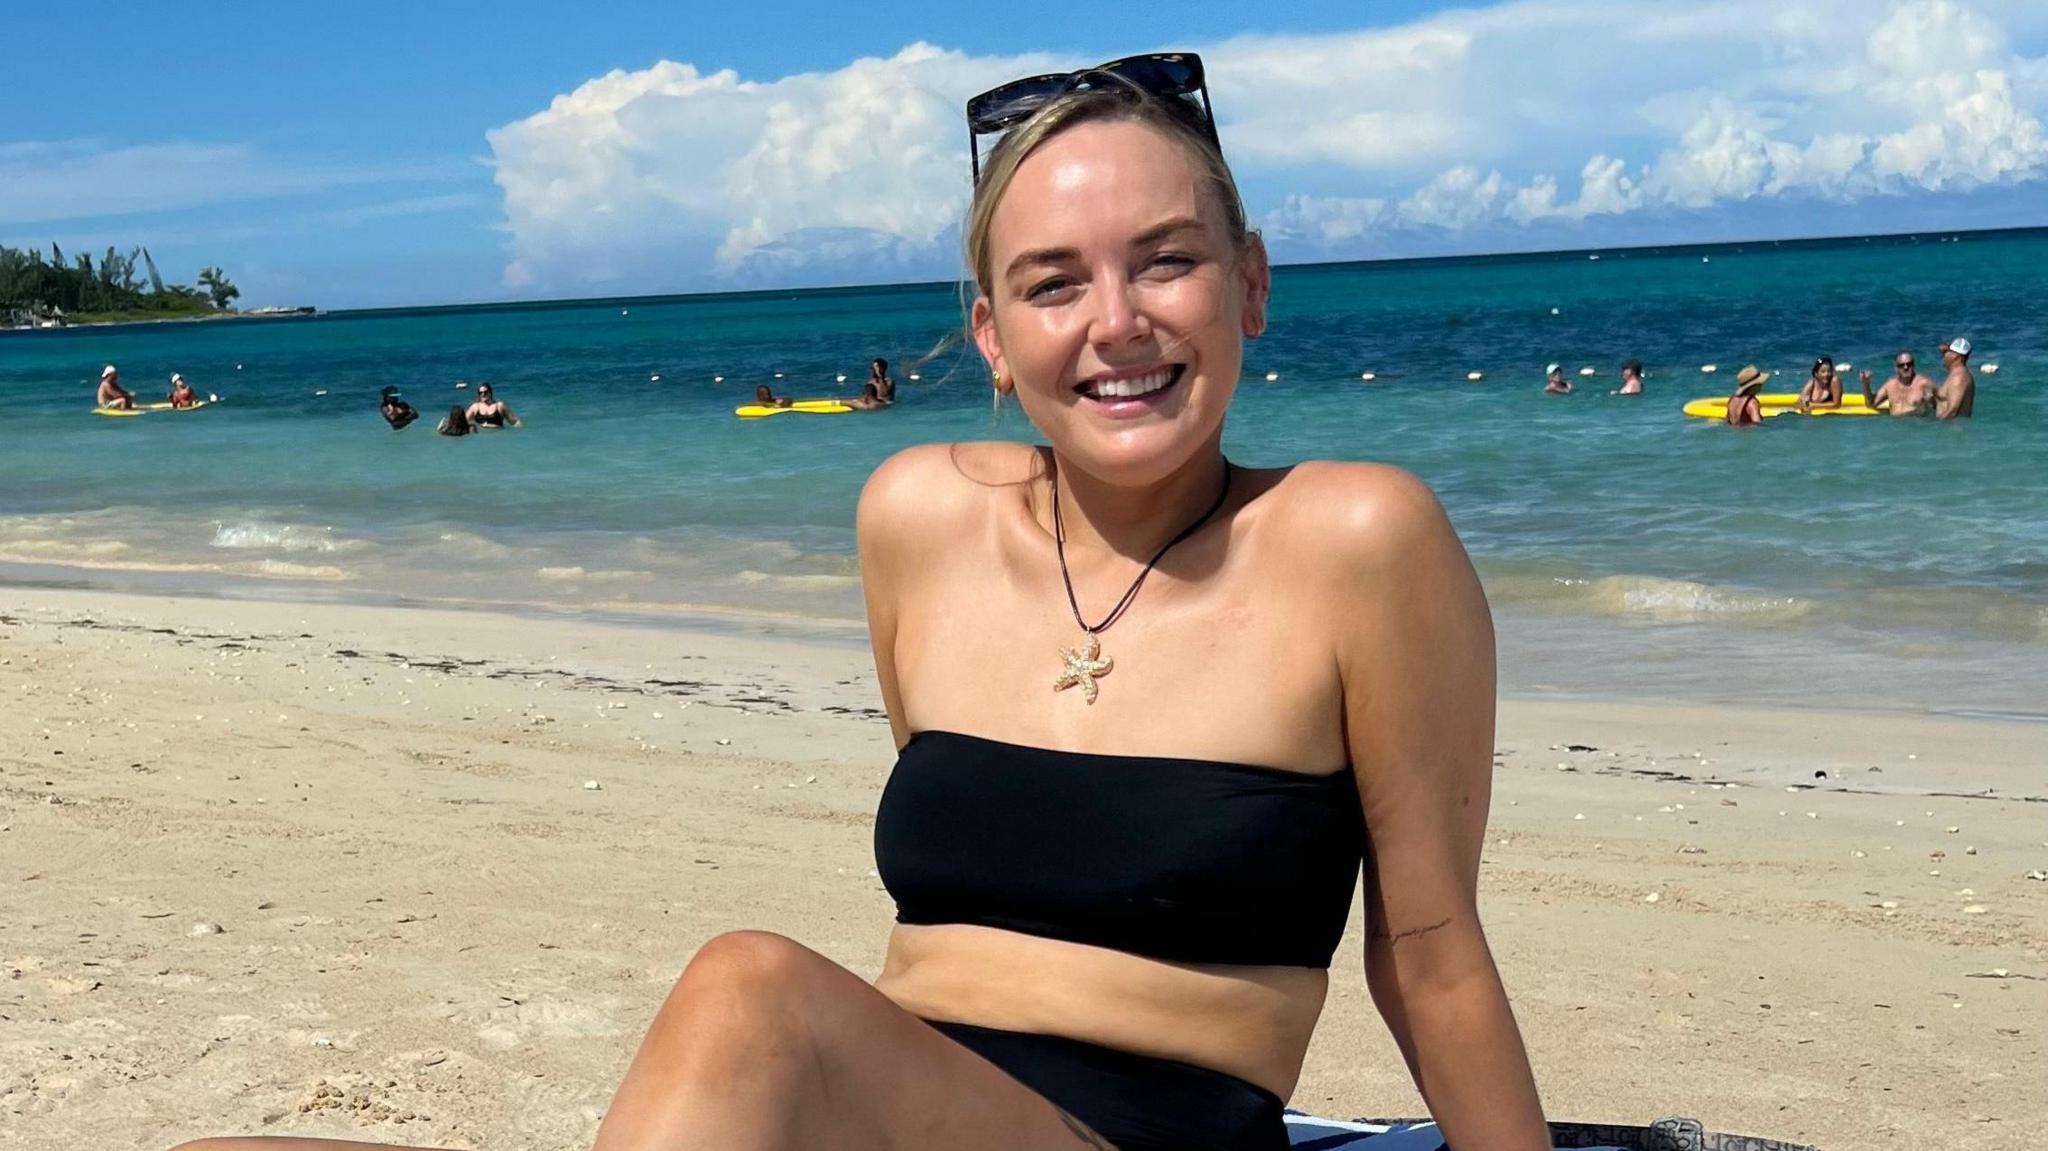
176,55 -> 1550,1151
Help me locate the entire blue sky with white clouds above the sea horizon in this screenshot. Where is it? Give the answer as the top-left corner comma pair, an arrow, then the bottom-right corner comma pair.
0,0 -> 2048,307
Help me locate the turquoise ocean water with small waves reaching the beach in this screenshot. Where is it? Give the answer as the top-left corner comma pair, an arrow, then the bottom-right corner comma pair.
0,231 -> 2048,715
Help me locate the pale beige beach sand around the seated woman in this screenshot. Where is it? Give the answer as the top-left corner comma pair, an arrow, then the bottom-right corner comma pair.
0,588 -> 2048,1151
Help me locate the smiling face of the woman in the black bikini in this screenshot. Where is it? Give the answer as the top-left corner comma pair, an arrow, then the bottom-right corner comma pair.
973,123 -> 1270,485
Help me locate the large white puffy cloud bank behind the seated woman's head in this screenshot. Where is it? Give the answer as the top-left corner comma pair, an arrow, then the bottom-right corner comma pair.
489,0 -> 2048,287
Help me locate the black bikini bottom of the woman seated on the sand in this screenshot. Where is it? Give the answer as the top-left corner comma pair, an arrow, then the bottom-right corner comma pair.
926,1020 -> 1286,1151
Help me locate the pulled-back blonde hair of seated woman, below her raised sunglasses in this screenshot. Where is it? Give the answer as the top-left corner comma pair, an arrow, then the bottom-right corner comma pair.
965,86 -> 1251,295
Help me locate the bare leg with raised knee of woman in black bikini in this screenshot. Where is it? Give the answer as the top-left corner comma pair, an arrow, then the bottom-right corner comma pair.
174,932 -> 1114,1151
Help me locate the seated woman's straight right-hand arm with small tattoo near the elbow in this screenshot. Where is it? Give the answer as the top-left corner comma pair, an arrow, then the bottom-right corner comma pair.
1329,467 -> 1550,1151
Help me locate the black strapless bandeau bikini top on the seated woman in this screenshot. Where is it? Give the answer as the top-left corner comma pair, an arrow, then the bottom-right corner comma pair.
874,731 -> 1364,969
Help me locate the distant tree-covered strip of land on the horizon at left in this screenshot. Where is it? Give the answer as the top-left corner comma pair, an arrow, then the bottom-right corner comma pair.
0,244 -> 313,328
